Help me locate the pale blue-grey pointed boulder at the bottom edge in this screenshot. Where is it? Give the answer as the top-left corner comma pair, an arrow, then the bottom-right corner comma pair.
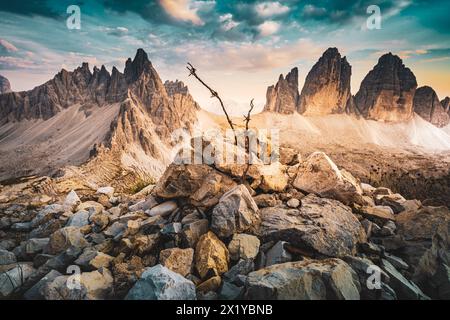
125,264 -> 196,300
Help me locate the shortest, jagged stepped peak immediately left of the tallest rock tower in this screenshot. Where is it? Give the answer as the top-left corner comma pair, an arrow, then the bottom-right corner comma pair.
264,68 -> 299,114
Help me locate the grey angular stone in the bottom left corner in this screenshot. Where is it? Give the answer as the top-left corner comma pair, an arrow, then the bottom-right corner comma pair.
0,263 -> 35,299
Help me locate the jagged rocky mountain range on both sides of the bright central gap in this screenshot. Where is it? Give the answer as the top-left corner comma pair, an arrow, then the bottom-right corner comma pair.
0,48 -> 450,188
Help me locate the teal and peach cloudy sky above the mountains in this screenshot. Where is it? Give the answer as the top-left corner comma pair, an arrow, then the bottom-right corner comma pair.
0,0 -> 450,114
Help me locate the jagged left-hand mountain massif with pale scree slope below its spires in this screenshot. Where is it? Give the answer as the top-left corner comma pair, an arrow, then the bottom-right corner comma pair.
0,49 -> 199,183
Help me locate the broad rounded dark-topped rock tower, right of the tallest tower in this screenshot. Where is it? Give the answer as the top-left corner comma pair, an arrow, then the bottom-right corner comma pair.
355,53 -> 417,122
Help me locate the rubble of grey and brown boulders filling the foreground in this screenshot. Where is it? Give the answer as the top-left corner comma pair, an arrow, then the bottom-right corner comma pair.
0,149 -> 450,300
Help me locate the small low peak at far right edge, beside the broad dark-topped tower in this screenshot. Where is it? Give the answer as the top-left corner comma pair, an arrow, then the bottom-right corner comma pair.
414,86 -> 450,128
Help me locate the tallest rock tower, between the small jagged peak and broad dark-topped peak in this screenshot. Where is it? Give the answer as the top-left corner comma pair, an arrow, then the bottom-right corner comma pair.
298,48 -> 352,116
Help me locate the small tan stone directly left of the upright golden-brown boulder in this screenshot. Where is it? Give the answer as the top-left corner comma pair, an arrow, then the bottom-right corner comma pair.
159,248 -> 194,277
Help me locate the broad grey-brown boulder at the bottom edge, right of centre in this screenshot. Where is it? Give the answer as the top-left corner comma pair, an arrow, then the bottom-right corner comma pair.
245,259 -> 360,300
